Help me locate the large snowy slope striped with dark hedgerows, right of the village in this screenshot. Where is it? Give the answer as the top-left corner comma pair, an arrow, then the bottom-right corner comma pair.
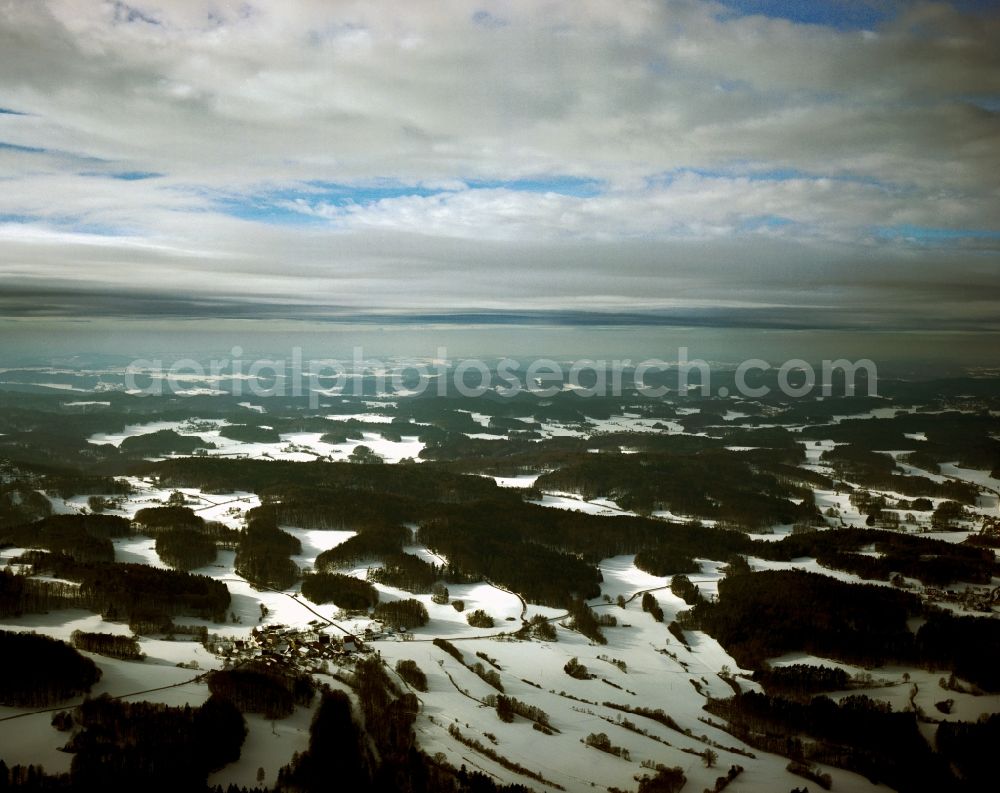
366,556 -> 892,793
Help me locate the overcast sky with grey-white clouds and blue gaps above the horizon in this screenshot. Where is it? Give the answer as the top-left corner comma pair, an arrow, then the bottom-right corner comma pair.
0,0 -> 1000,330
